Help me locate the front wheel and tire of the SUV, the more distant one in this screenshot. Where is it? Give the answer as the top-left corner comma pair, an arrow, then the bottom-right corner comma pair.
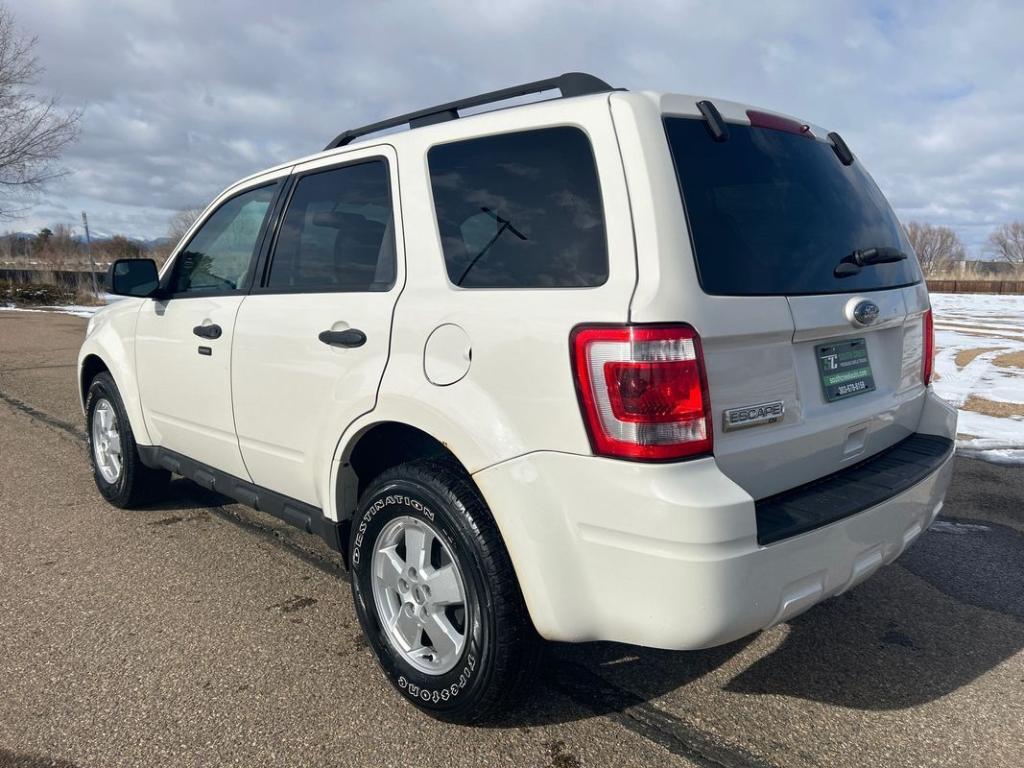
85,373 -> 171,509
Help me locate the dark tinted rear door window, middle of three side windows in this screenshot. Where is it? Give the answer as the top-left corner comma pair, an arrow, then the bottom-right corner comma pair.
267,160 -> 395,291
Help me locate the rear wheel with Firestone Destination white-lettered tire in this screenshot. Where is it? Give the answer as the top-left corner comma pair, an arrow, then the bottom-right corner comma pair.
349,459 -> 540,724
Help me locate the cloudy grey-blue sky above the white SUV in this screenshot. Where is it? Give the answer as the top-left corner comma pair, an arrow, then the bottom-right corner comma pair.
0,0 -> 1024,250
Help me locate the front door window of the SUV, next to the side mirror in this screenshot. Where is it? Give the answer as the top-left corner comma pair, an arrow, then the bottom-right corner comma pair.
169,184 -> 278,293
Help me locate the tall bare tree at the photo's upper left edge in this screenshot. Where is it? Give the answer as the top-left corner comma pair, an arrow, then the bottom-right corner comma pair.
0,5 -> 81,219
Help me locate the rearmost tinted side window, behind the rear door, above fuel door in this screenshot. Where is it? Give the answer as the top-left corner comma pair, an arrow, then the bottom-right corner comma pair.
427,127 -> 608,288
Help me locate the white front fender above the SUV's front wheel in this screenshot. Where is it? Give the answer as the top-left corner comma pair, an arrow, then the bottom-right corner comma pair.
78,299 -> 153,445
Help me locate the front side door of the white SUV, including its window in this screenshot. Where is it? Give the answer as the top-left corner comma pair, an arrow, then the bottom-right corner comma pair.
135,179 -> 282,479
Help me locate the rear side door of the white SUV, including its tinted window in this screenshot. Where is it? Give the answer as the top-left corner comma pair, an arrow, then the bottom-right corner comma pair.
231,146 -> 404,507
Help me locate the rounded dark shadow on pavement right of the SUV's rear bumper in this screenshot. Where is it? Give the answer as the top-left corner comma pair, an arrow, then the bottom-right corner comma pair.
726,518 -> 1024,711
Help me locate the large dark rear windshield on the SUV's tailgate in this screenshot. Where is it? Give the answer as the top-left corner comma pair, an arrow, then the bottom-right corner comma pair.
665,118 -> 921,296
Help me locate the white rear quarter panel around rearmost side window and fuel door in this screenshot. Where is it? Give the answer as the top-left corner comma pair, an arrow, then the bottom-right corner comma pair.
327,95 -> 636,514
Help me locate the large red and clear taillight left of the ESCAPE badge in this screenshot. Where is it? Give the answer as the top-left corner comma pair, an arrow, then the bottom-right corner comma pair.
571,325 -> 713,461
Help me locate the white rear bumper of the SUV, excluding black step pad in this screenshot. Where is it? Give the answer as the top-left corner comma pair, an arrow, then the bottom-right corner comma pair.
475,393 -> 955,649
